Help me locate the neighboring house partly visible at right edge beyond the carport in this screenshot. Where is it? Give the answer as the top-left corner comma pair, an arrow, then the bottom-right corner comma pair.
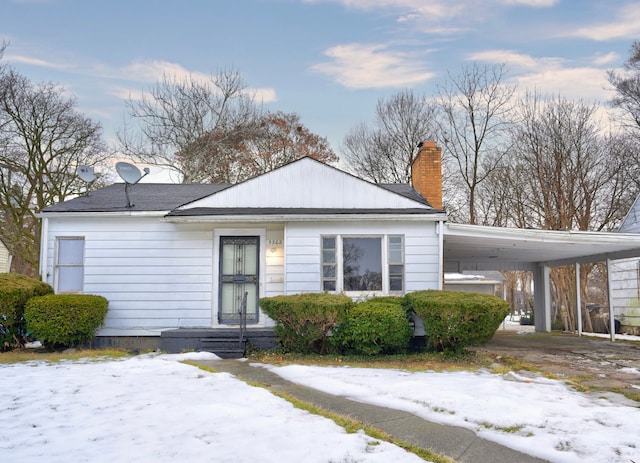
609,196 -> 640,335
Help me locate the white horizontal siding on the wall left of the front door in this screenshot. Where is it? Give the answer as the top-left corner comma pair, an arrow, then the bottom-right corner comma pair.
47,217 -> 218,336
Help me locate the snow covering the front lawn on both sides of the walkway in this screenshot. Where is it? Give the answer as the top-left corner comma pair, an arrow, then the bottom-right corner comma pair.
0,354 -> 640,463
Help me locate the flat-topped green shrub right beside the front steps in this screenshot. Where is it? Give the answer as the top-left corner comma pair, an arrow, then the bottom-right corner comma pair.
260,293 -> 353,353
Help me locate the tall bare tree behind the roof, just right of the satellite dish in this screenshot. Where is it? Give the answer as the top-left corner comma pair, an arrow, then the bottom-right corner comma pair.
118,70 -> 261,183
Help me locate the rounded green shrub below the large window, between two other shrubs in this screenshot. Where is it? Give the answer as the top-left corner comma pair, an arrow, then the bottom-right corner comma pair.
329,299 -> 413,355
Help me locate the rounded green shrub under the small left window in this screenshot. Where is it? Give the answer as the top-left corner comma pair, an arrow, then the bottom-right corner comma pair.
24,294 -> 109,347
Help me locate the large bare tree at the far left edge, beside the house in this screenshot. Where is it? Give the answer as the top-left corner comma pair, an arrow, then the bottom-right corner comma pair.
0,67 -> 108,275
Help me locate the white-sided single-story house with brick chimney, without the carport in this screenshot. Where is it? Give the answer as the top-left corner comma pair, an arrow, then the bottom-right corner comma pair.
40,143 -> 446,347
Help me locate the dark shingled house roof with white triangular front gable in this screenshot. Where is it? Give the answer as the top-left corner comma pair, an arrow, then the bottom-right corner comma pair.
42,157 -> 443,217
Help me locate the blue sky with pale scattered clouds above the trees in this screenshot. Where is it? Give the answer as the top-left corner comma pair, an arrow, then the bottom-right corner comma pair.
0,0 -> 640,160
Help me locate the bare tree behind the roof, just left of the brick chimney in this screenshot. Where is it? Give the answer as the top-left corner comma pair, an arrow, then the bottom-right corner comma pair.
342,90 -> 435,183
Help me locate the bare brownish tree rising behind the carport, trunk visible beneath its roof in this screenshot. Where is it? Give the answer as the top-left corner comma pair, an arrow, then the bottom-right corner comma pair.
500,94 -> 638,330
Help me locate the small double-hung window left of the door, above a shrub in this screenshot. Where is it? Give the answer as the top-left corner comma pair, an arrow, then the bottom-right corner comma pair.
55,236 -> 84,293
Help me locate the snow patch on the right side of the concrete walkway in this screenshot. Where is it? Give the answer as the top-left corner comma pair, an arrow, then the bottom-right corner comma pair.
268,365 -> 640,463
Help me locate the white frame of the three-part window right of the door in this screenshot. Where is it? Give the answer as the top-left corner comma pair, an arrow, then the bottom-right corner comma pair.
320,233 -> 405,297
